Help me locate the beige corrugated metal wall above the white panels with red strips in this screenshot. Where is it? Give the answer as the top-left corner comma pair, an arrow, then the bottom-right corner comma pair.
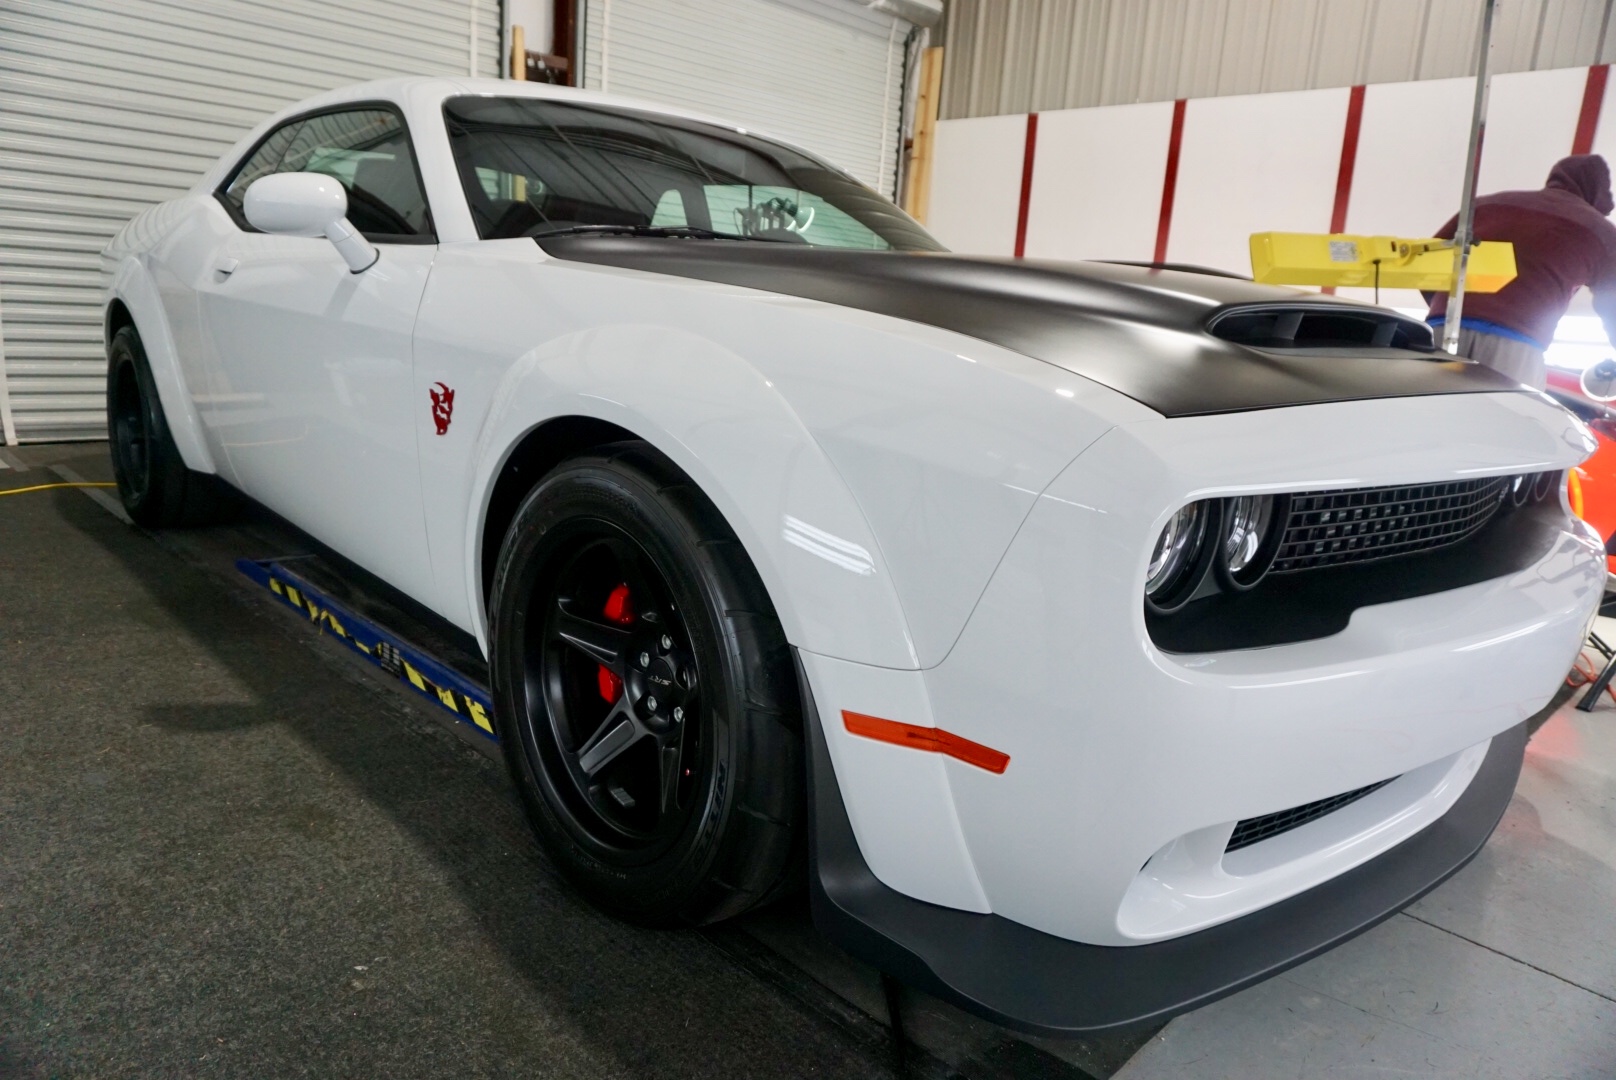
942,0 -> 1616,120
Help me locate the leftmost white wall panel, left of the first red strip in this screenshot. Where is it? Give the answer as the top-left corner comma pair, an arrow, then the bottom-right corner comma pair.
926,116 -> 1026,255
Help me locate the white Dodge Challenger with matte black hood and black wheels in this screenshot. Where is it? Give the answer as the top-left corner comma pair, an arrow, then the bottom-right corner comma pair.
105,79 -> 1605,1033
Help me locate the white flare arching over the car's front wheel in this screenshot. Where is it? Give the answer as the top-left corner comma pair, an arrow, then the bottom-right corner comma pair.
465,325 -> 920,669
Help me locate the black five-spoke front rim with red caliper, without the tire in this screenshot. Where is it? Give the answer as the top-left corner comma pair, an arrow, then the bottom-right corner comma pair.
524,522 -> 701,850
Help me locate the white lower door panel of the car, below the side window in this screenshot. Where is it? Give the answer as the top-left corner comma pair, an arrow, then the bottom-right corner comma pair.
200,233 -> 436,597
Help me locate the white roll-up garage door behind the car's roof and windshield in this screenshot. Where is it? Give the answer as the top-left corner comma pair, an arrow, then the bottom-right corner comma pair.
580,0 -> 910,194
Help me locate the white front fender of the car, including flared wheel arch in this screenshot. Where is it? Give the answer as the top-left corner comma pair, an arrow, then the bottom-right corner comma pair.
415,239 -> 1154,669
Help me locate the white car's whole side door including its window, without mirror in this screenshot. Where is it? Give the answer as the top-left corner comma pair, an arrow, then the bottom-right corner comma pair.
197,102 -> 438,598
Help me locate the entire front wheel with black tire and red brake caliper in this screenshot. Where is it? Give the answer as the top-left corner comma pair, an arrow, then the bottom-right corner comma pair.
490,443 -> 803,926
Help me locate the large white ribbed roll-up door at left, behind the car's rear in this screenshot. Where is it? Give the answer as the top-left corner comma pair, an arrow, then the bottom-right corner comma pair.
0,0 -> 501,441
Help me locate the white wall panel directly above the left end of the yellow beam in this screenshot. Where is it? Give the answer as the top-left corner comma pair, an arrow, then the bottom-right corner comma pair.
1167,89 -> 1348,273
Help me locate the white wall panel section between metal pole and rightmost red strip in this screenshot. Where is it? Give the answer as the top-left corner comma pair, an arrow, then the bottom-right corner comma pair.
1480,68 -> 1589,194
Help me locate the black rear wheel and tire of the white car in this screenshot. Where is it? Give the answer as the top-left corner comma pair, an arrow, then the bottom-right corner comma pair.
107,327 -> 223,529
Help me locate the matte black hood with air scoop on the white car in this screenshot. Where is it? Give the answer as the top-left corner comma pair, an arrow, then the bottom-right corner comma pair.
540,234 -> 1517,416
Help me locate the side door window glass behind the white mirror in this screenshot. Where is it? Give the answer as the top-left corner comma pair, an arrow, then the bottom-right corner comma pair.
221,108 -> 433,243
